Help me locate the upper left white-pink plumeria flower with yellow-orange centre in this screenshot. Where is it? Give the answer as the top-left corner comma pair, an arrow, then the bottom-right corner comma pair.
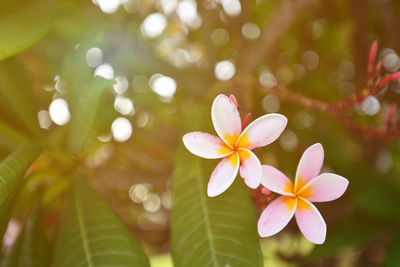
183,94 -> 287,197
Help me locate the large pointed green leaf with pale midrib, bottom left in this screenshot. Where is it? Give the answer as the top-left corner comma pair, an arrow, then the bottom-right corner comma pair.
52,174 -> 149,267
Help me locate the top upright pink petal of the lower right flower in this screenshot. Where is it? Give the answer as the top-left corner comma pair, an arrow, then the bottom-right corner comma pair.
294,143 -> 324,191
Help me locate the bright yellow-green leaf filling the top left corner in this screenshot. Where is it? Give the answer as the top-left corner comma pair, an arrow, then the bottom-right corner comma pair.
0,0 -> 55,60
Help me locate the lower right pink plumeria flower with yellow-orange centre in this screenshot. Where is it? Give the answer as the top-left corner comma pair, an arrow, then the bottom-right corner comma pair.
258,143 -> 349,244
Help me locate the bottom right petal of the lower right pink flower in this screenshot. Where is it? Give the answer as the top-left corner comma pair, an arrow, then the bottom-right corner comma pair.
295,197 -> 326,244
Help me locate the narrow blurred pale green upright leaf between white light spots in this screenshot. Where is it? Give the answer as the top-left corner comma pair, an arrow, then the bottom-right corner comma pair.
68,77 -> 115,153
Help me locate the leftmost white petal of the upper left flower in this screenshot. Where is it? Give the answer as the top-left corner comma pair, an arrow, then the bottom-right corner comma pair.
182,132 -> 233,159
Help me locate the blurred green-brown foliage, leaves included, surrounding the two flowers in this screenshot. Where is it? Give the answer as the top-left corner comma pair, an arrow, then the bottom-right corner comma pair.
0,0 -> 400,266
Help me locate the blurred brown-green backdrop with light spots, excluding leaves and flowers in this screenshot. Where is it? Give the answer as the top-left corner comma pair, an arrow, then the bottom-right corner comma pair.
0,0 -> 400,266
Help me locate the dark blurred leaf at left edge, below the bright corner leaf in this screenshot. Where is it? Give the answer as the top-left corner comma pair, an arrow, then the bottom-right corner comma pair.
0,58 -> 41,138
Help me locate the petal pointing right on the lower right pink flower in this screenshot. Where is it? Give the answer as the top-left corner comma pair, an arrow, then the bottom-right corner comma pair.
299,173 -> 349,202
